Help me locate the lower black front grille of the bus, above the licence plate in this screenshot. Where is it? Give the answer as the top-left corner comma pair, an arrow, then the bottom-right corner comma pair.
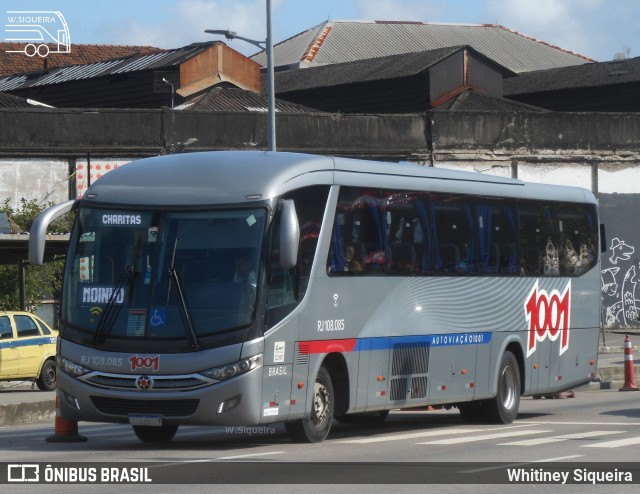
91,396 -> 200,417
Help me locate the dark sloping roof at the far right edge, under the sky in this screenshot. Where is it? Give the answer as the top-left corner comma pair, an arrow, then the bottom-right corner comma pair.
504,57 -> 640,96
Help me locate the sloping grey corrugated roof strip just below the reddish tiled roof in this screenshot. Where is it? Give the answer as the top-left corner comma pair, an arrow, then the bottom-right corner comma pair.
0,41 -> 221,91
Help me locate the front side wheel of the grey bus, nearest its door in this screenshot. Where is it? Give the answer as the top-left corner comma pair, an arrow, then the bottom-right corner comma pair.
284,367 -> 334,443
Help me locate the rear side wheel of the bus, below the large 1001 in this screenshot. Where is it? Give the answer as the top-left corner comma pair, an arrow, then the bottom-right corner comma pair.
483,352 -> 520,424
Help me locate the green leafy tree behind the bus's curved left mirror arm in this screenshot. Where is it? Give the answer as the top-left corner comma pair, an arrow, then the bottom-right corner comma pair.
0,198 -> 73,311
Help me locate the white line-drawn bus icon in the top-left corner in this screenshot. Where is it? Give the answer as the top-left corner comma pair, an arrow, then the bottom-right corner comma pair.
4,10 -> 71,58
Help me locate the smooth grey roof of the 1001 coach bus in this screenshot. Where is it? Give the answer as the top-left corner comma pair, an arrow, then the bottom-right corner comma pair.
84,151 -> 595,206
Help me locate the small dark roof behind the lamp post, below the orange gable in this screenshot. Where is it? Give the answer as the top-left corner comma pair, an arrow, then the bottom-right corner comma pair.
175,86 -> 318,113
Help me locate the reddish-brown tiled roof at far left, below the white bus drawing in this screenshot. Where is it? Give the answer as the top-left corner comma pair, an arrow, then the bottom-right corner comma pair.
0,42 -> 165,76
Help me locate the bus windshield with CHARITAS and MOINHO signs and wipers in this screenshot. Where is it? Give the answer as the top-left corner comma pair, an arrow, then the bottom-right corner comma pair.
62,208 -> 267,349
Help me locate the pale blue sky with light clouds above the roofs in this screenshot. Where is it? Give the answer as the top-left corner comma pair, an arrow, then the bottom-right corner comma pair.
0,0 -> 640,62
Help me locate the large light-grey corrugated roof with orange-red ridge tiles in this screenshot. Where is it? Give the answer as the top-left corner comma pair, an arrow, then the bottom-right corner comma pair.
252,21 -> 592,73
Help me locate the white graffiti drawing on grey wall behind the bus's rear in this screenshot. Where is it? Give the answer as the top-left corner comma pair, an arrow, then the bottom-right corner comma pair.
602,237 -> 640,328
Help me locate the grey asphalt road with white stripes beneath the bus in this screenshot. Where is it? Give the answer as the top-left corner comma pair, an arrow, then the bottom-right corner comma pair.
0,390 -> 640,493
